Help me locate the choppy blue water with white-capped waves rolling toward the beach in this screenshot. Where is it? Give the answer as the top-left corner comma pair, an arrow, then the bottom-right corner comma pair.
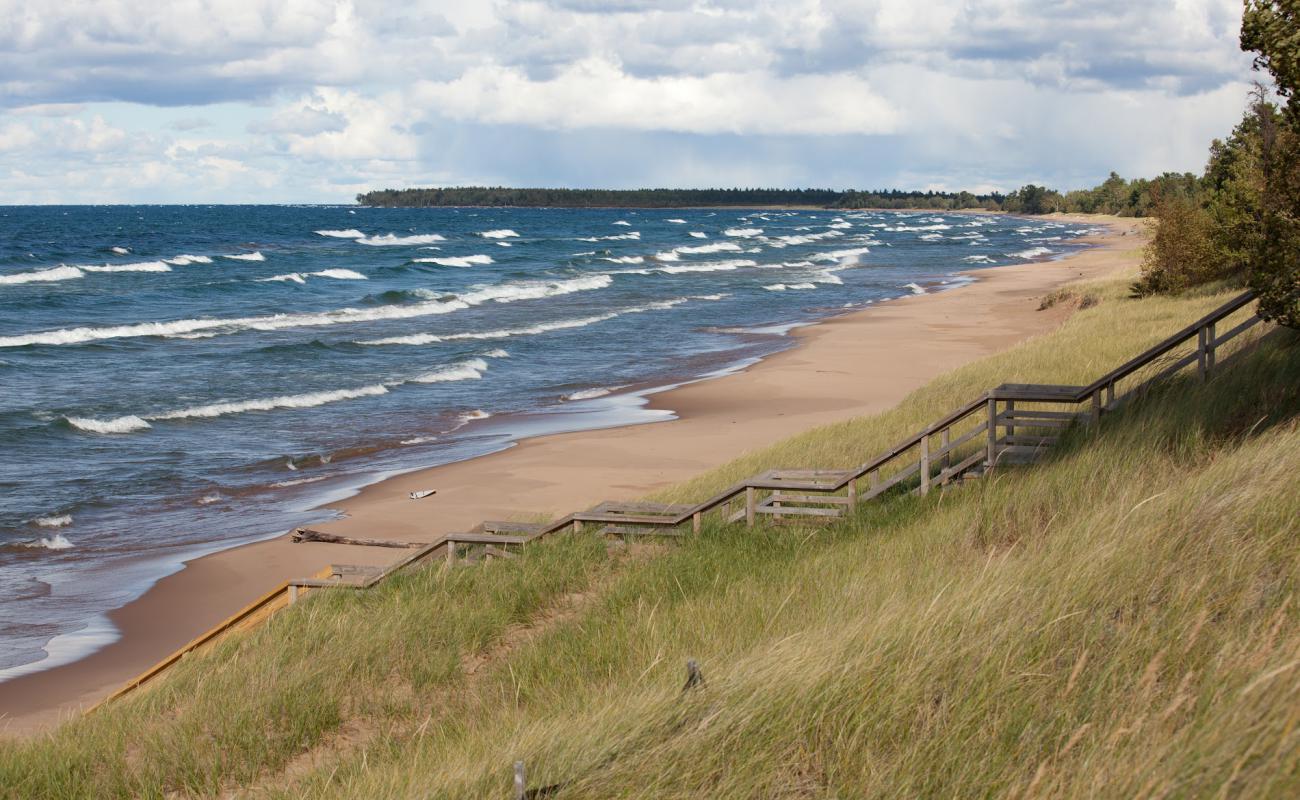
0,206 -> 1087,678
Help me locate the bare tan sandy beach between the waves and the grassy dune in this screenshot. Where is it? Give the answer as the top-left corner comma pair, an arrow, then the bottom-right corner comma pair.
0,211 -> 1140,734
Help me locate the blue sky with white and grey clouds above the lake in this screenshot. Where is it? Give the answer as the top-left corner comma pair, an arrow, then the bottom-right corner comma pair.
0,0 -> 1257,204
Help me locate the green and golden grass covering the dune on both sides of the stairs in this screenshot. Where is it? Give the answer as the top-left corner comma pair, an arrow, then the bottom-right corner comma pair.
0,274 -> 1300,797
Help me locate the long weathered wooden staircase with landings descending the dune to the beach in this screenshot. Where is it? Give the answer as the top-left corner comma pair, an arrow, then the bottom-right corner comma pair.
91,291 -> 1260,710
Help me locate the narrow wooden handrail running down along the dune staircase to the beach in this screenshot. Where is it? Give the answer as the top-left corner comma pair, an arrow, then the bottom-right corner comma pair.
87,291 -> 1260,713
